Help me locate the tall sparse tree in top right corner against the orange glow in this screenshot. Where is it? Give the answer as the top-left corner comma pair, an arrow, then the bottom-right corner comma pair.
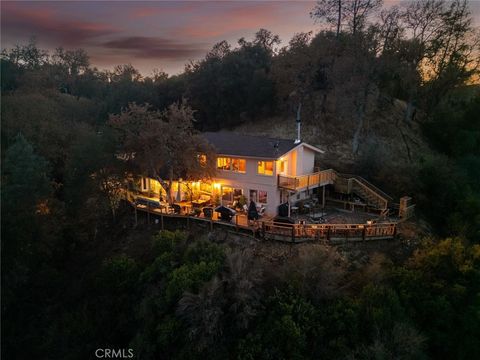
401,0 -> 480,121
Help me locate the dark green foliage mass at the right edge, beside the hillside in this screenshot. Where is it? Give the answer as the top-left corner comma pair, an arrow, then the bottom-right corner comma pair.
418,88 -> 480,241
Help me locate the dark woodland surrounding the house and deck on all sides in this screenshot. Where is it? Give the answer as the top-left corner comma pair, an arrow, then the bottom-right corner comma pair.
1,0 -> 480,359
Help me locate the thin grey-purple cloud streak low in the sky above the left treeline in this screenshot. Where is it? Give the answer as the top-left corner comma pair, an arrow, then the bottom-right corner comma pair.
102,36 -> 206,60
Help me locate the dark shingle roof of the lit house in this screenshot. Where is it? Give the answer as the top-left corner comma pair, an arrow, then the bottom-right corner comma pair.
203,132 -> 298,159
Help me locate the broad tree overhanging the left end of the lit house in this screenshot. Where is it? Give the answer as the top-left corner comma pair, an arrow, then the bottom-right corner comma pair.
109,102 -> 215,203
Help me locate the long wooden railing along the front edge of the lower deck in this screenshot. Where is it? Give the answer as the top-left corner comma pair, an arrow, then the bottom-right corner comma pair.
127,190 -> 397,243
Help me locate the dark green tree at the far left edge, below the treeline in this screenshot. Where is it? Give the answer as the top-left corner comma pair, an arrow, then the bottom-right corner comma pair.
1,134 -> 52,336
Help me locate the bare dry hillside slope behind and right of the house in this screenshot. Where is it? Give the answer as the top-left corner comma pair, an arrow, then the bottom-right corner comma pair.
231,100 -> 433,196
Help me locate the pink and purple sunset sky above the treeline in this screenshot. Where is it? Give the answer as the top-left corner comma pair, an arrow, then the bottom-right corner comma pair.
1,0 -> 480,75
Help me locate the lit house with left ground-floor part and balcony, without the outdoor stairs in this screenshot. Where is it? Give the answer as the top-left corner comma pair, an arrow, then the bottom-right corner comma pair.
141,132 -> 331,216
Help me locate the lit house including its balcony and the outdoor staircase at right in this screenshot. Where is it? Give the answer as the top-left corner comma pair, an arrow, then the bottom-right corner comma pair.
133,128 -> 415,219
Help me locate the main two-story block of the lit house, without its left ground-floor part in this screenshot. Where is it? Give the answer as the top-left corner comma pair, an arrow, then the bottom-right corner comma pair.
199,132 -> 322,215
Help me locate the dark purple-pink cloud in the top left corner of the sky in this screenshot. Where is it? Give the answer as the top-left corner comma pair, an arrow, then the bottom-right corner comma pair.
2,2 -> 118,46
